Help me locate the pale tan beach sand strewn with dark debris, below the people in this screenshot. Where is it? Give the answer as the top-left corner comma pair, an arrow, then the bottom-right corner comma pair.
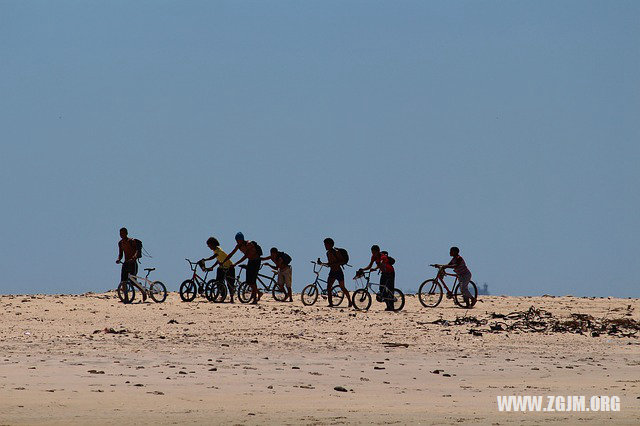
0,292 -> 640,425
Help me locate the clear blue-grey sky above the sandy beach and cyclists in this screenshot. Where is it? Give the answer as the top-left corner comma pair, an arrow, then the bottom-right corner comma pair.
0,0 -> 640,297
